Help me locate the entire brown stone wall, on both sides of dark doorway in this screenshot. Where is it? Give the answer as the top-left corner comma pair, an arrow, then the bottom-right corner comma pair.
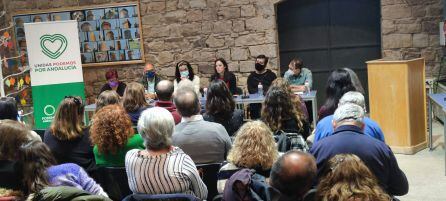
3,0 -> 443,102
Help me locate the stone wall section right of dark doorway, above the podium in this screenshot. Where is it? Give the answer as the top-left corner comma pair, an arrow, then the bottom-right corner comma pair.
381,0 -> 443,77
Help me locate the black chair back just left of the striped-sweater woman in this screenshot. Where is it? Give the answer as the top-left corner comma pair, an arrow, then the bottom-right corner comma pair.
91,167 -> 132,200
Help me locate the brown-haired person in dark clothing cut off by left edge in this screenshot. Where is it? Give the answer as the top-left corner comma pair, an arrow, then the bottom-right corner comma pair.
0,119 -> 29,192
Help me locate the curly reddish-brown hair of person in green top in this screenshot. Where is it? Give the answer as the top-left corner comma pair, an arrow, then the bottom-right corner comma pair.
90,104 -> 134,154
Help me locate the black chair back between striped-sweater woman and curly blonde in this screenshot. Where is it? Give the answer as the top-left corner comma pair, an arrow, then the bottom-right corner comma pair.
196,163 -> 221,200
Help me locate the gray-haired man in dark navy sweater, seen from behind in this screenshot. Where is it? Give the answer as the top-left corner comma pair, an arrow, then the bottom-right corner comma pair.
310,103 -> 409,195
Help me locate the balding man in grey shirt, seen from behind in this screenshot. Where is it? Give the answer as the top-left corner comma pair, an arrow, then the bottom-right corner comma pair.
172,89 -> 232,163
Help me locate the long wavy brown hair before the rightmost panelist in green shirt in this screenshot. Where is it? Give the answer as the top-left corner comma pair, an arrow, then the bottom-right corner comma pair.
262,87 -> 305,132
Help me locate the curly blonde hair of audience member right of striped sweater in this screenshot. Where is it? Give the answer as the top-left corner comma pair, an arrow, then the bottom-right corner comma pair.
228,121 -> 279,170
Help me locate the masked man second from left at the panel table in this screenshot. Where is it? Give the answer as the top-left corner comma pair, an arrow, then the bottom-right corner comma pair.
139,63 -> 163,99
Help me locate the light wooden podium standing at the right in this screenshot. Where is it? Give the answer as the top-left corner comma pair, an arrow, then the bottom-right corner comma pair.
366,58 -> 427,154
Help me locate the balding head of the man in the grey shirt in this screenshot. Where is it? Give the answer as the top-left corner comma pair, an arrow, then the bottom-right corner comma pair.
174,88 -> 200,117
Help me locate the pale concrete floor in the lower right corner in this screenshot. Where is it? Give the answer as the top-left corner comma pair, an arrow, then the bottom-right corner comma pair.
395,122 -> 446,201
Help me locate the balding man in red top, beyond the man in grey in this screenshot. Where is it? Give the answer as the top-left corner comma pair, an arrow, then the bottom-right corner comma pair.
155,80 -> 181,124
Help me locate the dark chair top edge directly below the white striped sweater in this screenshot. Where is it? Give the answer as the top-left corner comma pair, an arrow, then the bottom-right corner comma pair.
122,194 -> 200,201
